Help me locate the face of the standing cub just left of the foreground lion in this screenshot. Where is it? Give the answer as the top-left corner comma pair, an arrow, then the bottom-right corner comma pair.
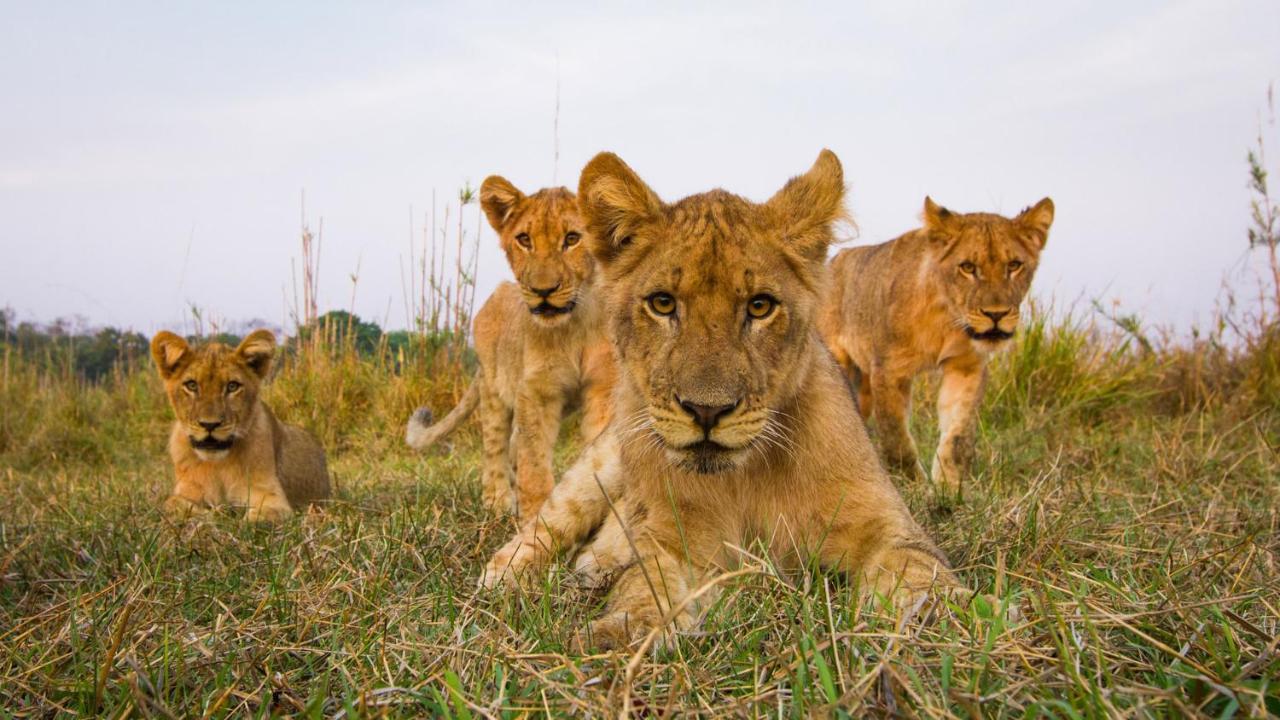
480,176 -> 594,325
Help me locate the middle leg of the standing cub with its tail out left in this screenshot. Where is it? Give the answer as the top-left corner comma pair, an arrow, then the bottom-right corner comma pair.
516,383 -> 564,518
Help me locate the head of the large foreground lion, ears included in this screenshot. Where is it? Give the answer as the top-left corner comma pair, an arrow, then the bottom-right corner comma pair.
579,151 -> 844,473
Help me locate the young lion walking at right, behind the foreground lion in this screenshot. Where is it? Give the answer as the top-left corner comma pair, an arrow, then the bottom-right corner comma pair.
818,197 -> 1053,495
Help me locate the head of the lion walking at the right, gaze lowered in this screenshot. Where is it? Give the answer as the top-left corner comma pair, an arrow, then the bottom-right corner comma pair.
924,197 -> 1053,348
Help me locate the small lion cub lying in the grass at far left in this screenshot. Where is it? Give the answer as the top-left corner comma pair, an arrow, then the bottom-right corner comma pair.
151,329 -> 329,523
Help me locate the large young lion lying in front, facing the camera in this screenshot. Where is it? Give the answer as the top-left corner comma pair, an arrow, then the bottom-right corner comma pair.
480,150 -> 960,647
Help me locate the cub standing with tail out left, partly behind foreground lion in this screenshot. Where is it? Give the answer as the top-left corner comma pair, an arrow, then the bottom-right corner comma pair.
406,176 -> 616,516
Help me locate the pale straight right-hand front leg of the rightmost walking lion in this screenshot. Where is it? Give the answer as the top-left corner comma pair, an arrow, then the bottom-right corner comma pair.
932,360 -> 987,495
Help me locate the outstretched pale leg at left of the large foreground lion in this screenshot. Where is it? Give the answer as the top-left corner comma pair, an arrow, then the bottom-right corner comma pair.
479,433 -> 622,588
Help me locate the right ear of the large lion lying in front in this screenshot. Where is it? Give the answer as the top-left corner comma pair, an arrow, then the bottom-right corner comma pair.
765,150 -> 845,263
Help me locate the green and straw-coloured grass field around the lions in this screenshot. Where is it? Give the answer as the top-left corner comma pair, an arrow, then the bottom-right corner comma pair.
0,304 -> 1280,717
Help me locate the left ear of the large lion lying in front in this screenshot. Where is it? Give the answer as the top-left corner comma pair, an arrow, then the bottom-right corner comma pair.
577,152 -> 662,264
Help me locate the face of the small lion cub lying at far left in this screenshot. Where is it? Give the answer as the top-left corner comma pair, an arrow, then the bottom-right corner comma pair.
151,331 -> 275,460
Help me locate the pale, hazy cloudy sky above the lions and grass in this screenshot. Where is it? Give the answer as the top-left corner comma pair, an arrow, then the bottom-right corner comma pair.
0,0 -> 1280,333
